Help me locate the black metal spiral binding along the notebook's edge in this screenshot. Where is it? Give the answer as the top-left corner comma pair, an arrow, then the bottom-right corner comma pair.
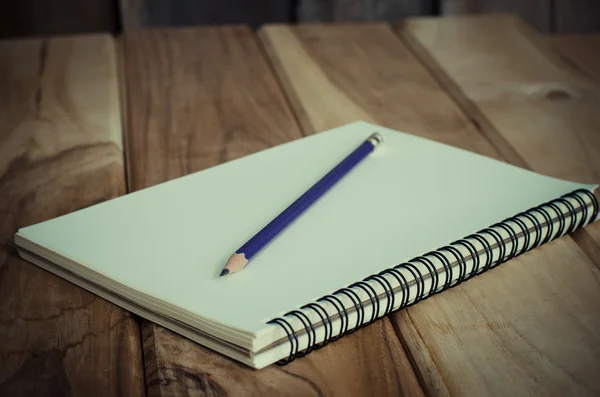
268,189 -> 599,365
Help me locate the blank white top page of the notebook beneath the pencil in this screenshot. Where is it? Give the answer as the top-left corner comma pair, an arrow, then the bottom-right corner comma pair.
20,122 -> 592,332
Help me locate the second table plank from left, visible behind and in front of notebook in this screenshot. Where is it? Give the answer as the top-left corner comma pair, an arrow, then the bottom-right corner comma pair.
124,26 -> 422,396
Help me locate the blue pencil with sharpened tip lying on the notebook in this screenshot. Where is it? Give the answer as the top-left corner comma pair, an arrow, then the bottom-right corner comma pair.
220,133 -> 383,277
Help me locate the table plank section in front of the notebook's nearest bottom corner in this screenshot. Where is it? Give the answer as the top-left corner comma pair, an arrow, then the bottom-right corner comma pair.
144,321 -> 423,397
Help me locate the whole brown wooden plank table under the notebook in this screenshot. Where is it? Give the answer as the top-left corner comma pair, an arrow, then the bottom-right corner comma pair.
0,16 -> 600,396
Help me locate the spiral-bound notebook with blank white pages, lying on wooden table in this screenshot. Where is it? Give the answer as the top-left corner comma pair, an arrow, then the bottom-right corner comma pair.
15,122 -> 598,368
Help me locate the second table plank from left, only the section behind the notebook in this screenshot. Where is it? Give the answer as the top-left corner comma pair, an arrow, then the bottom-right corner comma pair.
123,26 -> 302,191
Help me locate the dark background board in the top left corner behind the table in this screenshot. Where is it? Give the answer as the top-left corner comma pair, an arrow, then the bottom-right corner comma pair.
0,0 -> 118,38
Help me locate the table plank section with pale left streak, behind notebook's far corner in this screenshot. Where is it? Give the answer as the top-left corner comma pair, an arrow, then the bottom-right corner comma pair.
259,24 -> 498,157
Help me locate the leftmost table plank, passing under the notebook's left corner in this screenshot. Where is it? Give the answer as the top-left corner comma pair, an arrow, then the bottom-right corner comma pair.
0,35 -> 144,396
